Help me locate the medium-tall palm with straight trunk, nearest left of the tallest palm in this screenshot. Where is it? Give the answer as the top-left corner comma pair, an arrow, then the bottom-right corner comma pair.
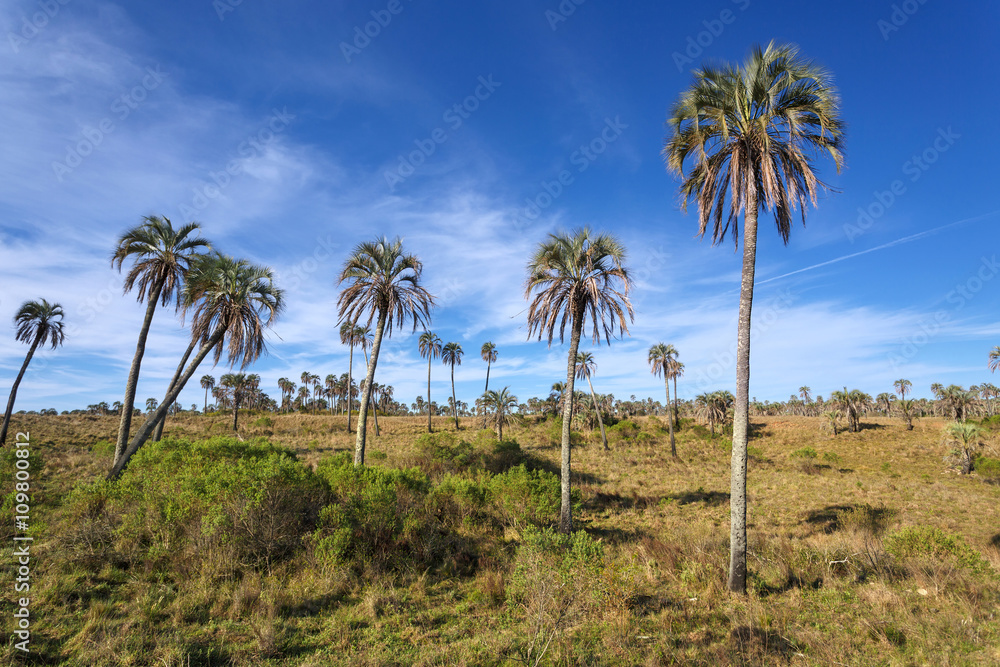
524,228 -> 634,534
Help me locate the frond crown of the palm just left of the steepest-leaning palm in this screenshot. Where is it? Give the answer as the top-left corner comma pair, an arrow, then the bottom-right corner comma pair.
111,216 -> 211,307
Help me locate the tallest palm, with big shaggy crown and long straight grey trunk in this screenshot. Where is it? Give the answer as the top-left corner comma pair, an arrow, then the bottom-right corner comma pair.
663,43 -> 844,593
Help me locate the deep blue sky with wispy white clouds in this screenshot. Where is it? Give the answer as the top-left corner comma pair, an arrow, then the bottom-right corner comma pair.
0,0 -> 1000,410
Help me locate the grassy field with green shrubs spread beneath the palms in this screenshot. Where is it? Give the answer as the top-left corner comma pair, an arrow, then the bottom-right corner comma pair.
0,414 -> 1000,666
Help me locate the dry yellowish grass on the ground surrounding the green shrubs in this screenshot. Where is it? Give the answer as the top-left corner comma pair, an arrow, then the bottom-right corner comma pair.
0,414 -> 1000,666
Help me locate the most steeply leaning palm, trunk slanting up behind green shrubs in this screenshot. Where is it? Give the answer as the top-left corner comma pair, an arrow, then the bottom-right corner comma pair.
108,255 -> 285,479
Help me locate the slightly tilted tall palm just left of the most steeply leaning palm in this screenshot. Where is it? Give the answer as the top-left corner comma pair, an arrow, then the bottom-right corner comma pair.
111,216 -> 210,464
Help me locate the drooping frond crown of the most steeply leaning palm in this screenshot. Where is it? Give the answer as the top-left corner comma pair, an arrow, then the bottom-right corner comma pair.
184,254 -> 285,368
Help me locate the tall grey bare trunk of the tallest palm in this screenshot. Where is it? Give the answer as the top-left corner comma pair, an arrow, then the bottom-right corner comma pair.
728,197 -> 757,594
